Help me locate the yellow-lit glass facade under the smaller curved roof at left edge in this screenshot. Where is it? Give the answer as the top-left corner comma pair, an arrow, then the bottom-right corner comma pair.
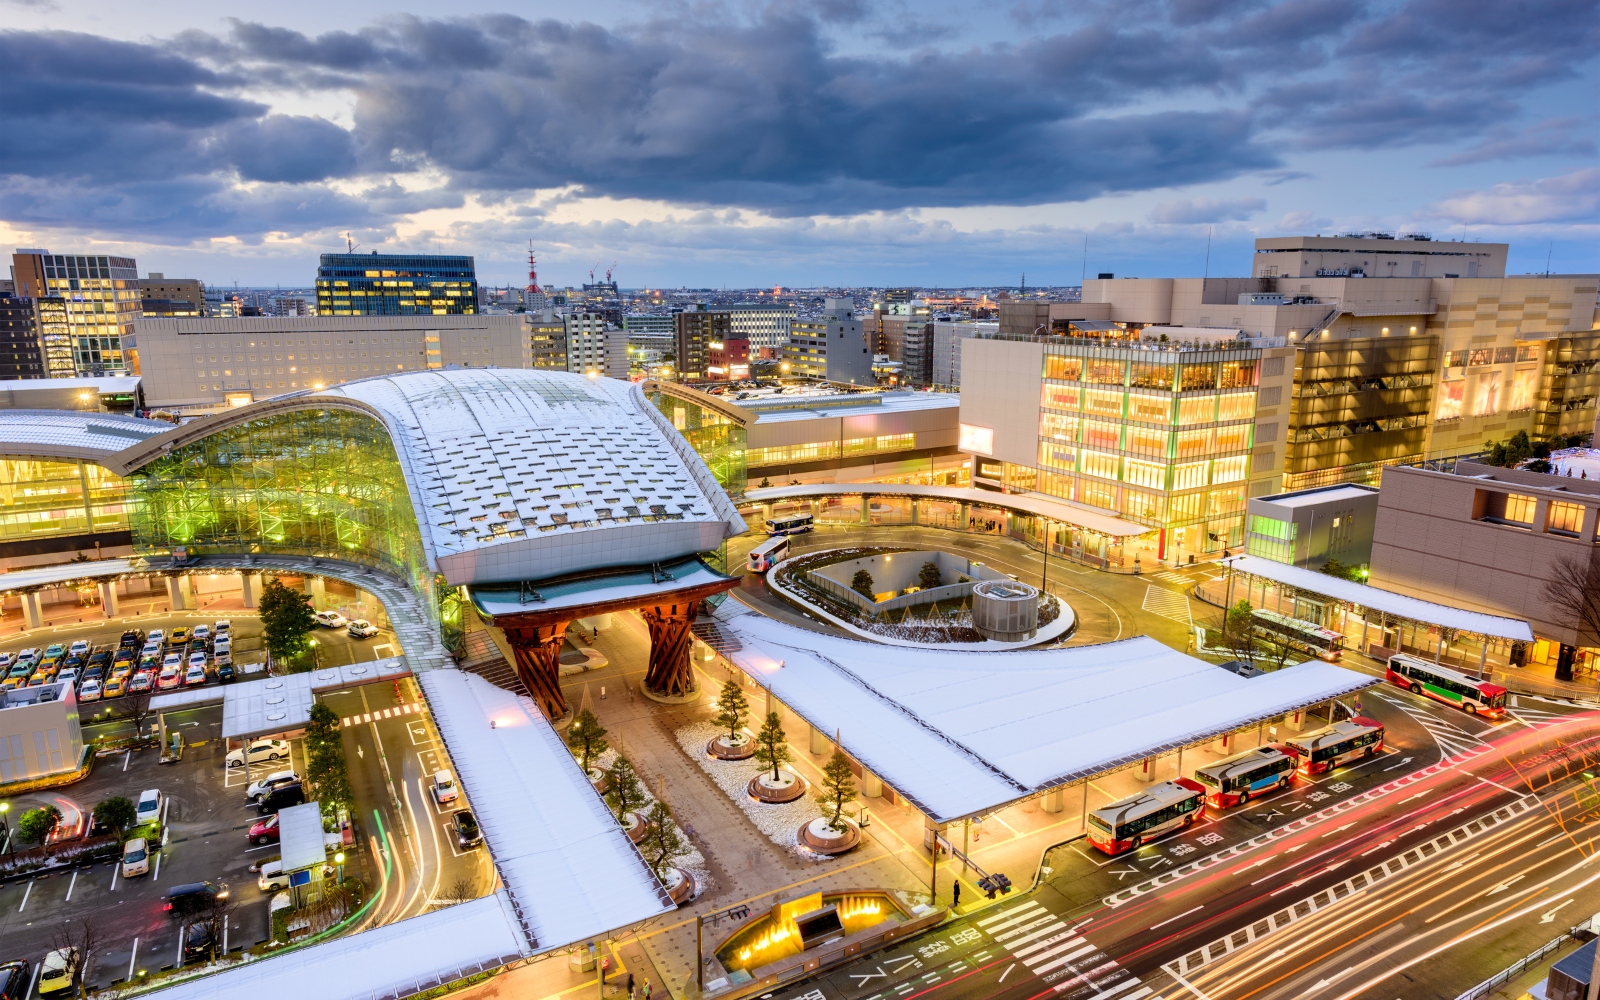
0,458 -> 131,542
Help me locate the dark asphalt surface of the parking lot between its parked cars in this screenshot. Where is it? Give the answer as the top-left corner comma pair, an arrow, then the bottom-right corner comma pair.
0,709 -> 292,987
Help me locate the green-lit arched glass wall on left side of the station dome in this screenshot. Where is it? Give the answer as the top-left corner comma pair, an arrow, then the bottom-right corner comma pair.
131,410 -> 434,594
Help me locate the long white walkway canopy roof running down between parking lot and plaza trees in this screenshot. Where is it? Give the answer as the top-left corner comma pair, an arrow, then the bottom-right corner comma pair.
421,669 -> 674,952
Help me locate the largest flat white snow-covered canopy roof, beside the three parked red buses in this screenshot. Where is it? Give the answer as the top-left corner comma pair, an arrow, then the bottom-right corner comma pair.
696,602 -> 1376,822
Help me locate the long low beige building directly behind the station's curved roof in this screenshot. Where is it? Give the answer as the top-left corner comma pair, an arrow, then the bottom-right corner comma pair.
139,315 -> 534,411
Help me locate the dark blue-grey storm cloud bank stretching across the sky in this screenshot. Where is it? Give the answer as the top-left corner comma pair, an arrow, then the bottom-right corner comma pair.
0,0 -> 1600,238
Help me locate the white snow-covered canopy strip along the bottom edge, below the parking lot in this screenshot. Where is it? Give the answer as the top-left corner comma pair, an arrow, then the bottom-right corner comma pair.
146,890 -> 528,1000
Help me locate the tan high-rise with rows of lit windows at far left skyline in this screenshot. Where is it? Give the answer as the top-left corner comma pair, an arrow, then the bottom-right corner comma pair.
11,250 -> 141,376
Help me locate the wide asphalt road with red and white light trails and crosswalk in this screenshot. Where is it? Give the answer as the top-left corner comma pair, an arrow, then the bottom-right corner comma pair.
758,688 -> 1600,1000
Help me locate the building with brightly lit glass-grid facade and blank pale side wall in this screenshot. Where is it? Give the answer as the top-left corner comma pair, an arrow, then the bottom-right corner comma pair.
962,330 -> 1294,558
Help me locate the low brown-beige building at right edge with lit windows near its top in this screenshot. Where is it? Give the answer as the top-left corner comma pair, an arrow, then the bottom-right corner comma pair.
1368,462 -> 1600,661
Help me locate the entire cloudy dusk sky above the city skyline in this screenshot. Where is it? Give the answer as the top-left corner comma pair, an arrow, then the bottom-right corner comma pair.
0,0 -> 1600,286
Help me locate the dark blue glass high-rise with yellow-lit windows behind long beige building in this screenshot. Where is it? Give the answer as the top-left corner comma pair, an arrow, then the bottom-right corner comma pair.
317,250 -> 478,317
